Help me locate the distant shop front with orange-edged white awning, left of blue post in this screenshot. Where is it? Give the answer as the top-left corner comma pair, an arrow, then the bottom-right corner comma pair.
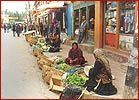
33,1 -> 67,33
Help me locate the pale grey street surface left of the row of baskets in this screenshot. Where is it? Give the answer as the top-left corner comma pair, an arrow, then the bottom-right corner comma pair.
1,29 -> 57,99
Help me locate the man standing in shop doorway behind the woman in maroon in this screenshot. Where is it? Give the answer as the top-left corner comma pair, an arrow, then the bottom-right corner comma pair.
78,16 -> 87,44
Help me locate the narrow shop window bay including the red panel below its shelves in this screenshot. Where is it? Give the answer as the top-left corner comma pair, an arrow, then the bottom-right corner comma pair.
105,2 -> 117,47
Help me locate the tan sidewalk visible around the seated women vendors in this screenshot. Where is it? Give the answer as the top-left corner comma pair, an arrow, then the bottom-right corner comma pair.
44,44 -> 127,99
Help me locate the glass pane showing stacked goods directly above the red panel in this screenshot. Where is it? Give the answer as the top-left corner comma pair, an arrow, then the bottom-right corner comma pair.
105,2 -> 117,33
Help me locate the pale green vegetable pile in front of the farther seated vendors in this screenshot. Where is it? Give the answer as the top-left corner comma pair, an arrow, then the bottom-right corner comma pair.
36,38 -> 51,51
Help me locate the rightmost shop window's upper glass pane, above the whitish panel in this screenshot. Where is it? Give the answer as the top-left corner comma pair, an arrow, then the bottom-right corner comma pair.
119,1 -> 135,34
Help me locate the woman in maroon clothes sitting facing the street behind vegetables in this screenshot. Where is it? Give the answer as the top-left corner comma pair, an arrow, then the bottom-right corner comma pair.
65,42 -> 86,65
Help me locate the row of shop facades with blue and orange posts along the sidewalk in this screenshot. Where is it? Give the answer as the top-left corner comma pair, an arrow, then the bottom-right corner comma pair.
30,1 -> 138,55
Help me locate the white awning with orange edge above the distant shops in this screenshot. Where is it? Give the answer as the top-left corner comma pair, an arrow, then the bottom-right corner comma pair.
32,1 -> 64,14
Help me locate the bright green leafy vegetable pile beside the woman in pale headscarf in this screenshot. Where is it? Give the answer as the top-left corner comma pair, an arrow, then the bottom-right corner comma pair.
65,72 -> 88,87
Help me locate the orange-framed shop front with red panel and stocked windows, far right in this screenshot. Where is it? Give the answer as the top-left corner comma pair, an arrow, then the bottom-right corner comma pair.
102,1 -> 137,54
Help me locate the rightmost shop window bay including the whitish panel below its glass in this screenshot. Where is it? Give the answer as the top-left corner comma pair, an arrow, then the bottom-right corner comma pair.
119,1 -> 135,51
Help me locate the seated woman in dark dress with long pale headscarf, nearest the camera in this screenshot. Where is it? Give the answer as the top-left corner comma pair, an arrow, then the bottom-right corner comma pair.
85,49 -> 117,95
